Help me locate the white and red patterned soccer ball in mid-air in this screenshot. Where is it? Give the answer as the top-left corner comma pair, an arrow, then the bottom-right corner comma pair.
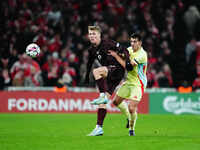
26,43 -> 40,57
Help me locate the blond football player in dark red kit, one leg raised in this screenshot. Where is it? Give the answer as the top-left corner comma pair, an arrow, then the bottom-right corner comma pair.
85,26 -> 129,136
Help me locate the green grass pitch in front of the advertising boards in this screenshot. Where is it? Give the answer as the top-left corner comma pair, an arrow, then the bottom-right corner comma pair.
0,114 -> 200,150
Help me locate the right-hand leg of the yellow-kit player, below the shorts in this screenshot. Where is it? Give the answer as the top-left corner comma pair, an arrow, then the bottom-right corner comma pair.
129,100 -> 139,136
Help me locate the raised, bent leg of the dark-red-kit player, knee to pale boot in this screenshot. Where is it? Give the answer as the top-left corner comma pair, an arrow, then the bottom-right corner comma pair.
91,66 -> 108,105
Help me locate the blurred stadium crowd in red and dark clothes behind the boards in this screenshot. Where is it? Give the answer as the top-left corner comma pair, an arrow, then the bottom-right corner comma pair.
0,0 -> 200,89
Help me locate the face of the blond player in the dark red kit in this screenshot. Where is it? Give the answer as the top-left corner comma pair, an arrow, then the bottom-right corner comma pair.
88,30 -> 101,45
